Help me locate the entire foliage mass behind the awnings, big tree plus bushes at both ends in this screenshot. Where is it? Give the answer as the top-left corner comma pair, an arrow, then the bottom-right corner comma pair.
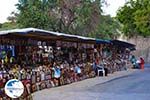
2,0 -> 120,39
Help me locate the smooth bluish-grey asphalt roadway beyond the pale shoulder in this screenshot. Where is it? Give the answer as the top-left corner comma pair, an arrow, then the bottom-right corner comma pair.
87,69 -> 150,100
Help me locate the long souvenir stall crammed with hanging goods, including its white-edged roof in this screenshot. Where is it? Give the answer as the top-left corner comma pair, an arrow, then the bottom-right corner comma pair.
0,28 -> 136,100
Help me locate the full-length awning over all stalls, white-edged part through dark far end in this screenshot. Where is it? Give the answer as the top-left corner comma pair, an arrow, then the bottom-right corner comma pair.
0,28 -> 135,47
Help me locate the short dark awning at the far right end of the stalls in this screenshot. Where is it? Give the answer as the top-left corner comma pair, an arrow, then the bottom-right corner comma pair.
111,40 -> 136,51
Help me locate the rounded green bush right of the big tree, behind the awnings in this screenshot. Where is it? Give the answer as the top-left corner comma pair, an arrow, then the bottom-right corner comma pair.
91,15 -> 121,39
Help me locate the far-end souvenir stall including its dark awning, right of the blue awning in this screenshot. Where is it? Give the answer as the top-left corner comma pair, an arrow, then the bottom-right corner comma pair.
97,40 -> 135,73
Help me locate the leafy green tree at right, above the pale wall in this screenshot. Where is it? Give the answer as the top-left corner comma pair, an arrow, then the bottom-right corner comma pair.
117,0 -> 150,36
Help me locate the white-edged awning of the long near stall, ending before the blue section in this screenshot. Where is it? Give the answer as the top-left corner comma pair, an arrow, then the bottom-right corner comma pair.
0,28 -> 95,42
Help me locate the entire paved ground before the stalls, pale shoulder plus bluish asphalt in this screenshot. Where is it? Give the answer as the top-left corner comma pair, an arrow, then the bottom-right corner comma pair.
34,68 -> 150,100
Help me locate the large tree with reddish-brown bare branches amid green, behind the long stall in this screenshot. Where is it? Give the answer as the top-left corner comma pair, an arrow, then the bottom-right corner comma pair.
17,0 -> 101,35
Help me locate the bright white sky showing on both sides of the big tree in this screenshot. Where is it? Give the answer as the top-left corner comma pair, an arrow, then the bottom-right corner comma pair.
0,0 -> 126,23
